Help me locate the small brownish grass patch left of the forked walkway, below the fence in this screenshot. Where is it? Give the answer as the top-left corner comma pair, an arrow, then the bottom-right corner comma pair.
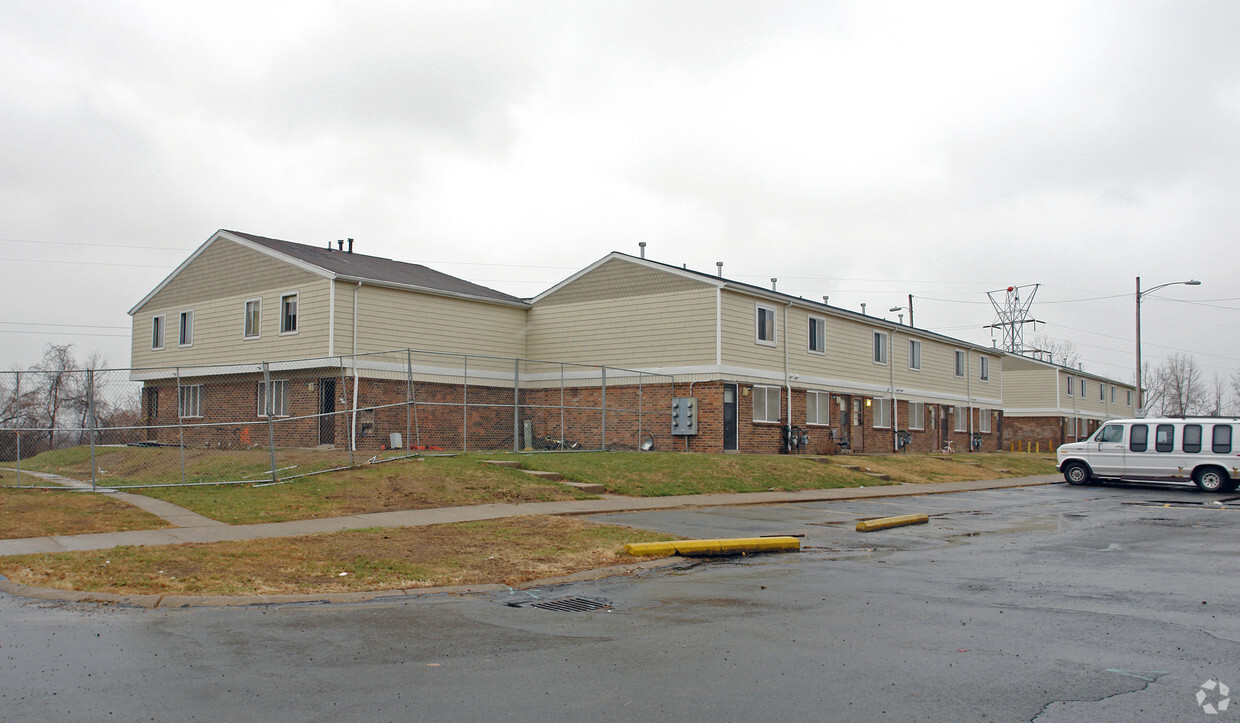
0,490 -> 171,539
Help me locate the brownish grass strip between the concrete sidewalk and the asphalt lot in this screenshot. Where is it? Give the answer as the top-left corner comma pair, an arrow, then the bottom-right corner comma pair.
0,516 -> 676,595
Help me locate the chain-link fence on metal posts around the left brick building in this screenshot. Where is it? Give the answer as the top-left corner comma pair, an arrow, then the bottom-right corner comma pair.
0,350 -> 675,487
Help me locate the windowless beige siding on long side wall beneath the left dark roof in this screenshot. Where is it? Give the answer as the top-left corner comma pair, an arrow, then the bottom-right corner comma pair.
336,282 -> 526,357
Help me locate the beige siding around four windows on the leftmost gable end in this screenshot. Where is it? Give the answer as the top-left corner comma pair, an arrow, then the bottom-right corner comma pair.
131,239 -> 330,368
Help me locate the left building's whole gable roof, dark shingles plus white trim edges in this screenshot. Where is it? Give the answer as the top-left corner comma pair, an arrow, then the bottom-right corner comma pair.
129,228 -> 528,315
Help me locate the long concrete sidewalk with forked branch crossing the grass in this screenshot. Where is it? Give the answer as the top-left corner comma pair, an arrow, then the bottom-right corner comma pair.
0,475 -> 1063,557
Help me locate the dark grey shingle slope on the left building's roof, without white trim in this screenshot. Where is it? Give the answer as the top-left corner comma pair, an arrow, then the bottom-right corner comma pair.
226,229 -> 525,304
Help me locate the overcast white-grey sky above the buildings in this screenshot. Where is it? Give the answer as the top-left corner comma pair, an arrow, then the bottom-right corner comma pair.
0,0 -> 1240,389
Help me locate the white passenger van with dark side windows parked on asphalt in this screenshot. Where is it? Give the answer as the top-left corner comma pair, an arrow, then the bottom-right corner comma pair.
1055,417 -> 1240,492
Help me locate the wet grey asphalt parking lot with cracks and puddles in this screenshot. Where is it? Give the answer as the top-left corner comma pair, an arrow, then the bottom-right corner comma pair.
0,485 -> 1240,722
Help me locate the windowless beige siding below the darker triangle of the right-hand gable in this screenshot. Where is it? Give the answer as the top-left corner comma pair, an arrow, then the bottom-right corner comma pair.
527,284 -> 715,368
